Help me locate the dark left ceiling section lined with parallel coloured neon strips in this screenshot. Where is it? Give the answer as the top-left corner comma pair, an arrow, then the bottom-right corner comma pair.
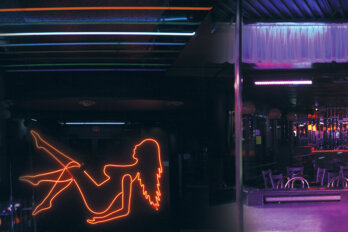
0,0 -> 211,72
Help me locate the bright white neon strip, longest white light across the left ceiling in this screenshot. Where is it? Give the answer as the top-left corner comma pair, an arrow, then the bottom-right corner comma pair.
0,31 -> 195,37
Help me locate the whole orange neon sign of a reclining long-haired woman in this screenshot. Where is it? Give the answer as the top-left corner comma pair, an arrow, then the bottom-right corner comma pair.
19,130 -> 163,224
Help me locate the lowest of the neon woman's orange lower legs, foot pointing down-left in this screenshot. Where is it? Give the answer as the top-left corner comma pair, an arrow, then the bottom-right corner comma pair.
32,169 -> 73,215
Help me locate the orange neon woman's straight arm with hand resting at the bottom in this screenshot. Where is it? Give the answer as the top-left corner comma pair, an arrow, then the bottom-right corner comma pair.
87,174 -> 133,224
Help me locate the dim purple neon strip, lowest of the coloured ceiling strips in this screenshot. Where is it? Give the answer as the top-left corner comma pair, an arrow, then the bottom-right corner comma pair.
6,68 -> 167,72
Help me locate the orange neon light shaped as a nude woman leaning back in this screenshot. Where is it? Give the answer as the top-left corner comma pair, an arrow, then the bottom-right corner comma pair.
20,130 -> 163,224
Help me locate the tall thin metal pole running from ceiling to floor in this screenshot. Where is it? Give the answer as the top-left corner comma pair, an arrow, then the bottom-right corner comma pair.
234,0 -> 243,232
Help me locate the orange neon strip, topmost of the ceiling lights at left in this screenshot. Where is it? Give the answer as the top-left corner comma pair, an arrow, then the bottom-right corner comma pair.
0,6 -> 212,12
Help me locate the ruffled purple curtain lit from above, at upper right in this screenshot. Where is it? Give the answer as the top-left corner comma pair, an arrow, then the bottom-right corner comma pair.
243,23 -> 348,63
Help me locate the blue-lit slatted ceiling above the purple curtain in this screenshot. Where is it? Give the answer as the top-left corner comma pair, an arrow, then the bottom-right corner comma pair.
215,0 -> 348,23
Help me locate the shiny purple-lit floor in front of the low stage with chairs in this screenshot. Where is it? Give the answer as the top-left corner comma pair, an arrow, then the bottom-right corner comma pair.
211,202 -> 348,232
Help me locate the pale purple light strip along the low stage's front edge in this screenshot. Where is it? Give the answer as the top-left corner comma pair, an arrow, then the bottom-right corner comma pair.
265,195 -> 341,202
